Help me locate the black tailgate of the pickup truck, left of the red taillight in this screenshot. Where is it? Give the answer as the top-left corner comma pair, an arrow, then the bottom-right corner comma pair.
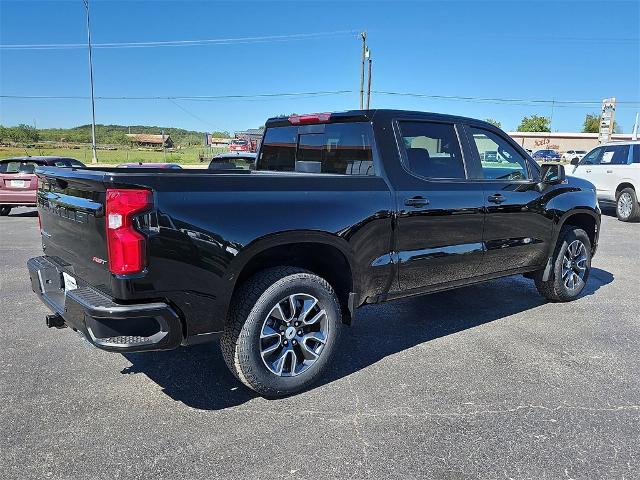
37,168 -> 111,294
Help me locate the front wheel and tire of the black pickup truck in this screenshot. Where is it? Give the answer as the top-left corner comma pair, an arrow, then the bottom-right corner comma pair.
534,225 -> 591,302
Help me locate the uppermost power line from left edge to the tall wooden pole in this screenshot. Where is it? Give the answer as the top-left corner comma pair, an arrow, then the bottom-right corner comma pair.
0,30 -> 357,50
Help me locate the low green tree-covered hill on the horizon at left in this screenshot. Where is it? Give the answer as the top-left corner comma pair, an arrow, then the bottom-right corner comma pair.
0,124 -> 231,146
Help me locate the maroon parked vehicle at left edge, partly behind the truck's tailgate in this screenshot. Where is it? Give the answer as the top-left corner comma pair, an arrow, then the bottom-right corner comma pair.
0,157 -> 85,216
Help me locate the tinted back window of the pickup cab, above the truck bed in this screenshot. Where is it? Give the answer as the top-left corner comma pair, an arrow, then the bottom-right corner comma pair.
257,123 -> 374,175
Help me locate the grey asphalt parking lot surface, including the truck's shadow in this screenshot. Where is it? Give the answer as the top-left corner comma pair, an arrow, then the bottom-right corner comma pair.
0,209 -> 640,479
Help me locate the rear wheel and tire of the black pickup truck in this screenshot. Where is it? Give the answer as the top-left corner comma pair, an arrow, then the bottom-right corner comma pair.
221,267 -> 342,398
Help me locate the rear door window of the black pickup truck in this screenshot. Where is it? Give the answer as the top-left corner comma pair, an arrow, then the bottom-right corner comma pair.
399,121 -> 466,179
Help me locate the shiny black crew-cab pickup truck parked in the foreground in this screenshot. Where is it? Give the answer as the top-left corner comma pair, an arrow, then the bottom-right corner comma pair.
28,110 -> 600,396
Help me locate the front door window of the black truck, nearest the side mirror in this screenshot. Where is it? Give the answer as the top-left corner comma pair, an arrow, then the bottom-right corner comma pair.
469,127 -> 530,180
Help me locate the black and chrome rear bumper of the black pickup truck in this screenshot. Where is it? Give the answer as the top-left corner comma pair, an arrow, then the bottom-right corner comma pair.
27,256 -> 183,352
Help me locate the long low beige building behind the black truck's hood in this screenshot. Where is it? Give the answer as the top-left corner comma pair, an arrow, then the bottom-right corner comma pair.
508,132 -> 631,152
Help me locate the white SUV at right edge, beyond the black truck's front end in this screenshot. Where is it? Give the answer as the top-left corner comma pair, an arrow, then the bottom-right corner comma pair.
569,141 -> 640,222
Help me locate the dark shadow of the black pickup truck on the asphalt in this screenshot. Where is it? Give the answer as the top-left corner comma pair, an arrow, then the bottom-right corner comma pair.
122,268 -> 614,410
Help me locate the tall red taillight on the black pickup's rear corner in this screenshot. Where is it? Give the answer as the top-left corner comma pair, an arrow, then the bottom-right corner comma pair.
106,189 -> 153,275
